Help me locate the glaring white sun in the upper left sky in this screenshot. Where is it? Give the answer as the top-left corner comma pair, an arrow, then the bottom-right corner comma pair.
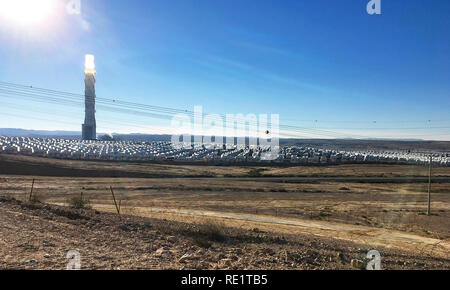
0,0 -> 56,25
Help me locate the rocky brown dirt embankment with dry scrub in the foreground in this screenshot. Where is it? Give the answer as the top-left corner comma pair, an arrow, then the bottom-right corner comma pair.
0,198 -> 450,269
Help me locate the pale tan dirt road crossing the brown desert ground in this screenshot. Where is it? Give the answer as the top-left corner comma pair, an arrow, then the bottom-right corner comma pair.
92,205 -> 450,258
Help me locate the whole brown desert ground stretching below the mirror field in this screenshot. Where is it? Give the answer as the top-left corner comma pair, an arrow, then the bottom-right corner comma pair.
0,155 -> 450,269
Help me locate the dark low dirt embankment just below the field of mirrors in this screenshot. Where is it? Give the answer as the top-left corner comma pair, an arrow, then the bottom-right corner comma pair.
0,154 -> 450,182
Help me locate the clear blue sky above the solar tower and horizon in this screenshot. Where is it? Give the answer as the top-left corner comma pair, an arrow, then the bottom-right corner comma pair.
0,0 -> 450,140
